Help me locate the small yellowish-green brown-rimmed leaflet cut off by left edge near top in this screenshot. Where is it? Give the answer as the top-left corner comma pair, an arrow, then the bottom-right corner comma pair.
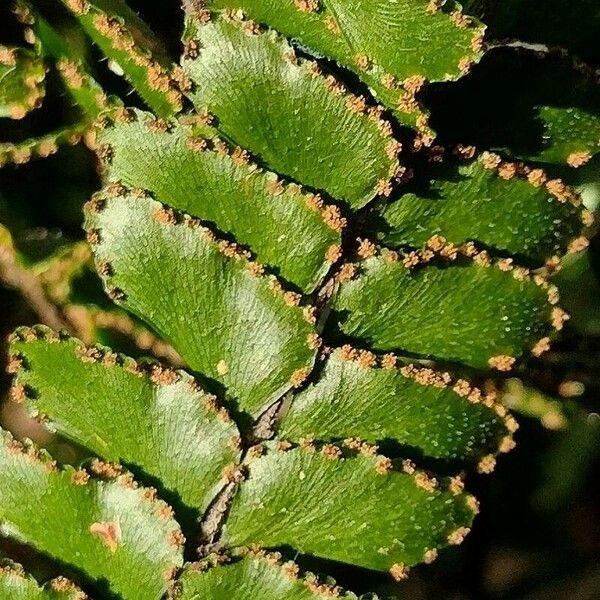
0,46 -> 46,119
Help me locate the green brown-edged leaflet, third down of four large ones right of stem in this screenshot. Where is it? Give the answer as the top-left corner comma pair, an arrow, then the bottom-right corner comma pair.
279,348 -> 508,459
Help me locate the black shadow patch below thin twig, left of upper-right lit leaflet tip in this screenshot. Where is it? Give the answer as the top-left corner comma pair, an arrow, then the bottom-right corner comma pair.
420,47 -> 600,157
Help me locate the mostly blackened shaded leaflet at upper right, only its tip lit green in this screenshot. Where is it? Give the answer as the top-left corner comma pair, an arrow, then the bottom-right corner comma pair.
427,48 -> 600,166
